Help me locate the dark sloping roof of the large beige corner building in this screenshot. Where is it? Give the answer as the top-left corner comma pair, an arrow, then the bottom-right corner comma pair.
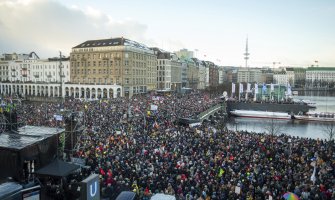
73,37 -> 150,50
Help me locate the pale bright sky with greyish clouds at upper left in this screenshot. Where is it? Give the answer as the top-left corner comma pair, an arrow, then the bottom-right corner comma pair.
0,0 -> 335,67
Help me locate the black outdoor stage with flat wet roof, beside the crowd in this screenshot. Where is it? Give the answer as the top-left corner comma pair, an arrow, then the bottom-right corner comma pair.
0,126 -> 65,182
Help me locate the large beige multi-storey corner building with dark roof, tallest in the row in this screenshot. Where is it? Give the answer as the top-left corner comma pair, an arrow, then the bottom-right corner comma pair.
70,38 -> 157,97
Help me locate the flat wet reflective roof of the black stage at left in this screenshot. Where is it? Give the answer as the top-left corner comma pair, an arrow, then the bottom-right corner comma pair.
0,126 -> 64,150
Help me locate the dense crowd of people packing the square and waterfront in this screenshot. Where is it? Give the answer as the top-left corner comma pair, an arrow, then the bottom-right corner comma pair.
8,91 -> 335,200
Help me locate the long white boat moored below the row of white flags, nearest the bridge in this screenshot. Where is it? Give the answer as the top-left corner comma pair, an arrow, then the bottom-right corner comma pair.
230,110 -> 292,119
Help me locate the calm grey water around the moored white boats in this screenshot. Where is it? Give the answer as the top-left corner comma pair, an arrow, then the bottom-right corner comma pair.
227,91 -> 335,139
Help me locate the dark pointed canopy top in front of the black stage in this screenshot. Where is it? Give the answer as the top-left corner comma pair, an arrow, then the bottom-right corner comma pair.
35,160 -> 80,177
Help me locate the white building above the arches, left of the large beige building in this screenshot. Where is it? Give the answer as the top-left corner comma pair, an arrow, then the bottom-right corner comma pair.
0,52 -> 70,83
